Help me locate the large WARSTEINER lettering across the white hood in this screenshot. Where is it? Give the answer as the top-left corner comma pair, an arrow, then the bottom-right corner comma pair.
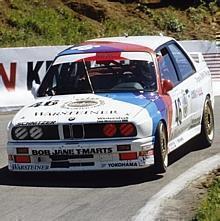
34,110 -> 117,117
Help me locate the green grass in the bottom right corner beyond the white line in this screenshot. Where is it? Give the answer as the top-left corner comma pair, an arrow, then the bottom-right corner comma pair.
193,177 -> 220,221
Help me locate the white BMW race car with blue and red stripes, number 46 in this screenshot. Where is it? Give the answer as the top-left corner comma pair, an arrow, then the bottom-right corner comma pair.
7,36 -> 214,173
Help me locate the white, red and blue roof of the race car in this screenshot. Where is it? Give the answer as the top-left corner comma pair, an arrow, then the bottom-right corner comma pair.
59,36 -> 174,55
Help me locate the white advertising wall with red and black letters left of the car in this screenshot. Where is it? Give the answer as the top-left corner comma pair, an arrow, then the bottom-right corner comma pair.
0,46 -> 68,109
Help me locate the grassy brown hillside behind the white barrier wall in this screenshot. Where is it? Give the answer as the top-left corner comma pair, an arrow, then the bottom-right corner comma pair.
0,0 -> 220,47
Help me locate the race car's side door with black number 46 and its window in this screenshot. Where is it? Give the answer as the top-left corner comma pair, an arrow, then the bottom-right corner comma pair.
157,42 -> 194,146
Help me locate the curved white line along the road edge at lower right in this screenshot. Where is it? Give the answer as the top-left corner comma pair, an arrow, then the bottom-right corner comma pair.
132,154 -> 220,221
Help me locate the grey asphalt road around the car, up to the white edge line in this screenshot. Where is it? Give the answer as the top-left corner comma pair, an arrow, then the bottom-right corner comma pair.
0,97 -> 220,221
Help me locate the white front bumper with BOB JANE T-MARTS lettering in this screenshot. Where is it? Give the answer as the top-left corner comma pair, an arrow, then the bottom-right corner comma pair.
7,137 -> 154,172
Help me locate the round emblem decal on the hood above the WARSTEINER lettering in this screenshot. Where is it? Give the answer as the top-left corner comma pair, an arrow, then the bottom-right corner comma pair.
61,97 -> 105,109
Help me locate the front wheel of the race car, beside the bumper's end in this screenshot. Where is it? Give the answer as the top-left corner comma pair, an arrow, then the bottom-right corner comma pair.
154,121 -> 168,173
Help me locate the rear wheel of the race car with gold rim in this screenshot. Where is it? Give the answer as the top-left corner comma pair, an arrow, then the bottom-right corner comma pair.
197,97 -> 215,148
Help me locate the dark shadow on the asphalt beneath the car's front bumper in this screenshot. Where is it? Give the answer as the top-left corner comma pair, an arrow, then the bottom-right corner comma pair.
0,167 -> 163,188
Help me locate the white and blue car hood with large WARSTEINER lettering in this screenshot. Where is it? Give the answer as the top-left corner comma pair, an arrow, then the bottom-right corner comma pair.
12,93 -> 154,125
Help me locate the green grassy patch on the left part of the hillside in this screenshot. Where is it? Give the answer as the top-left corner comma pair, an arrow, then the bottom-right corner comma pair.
0,0 -> 96,46
